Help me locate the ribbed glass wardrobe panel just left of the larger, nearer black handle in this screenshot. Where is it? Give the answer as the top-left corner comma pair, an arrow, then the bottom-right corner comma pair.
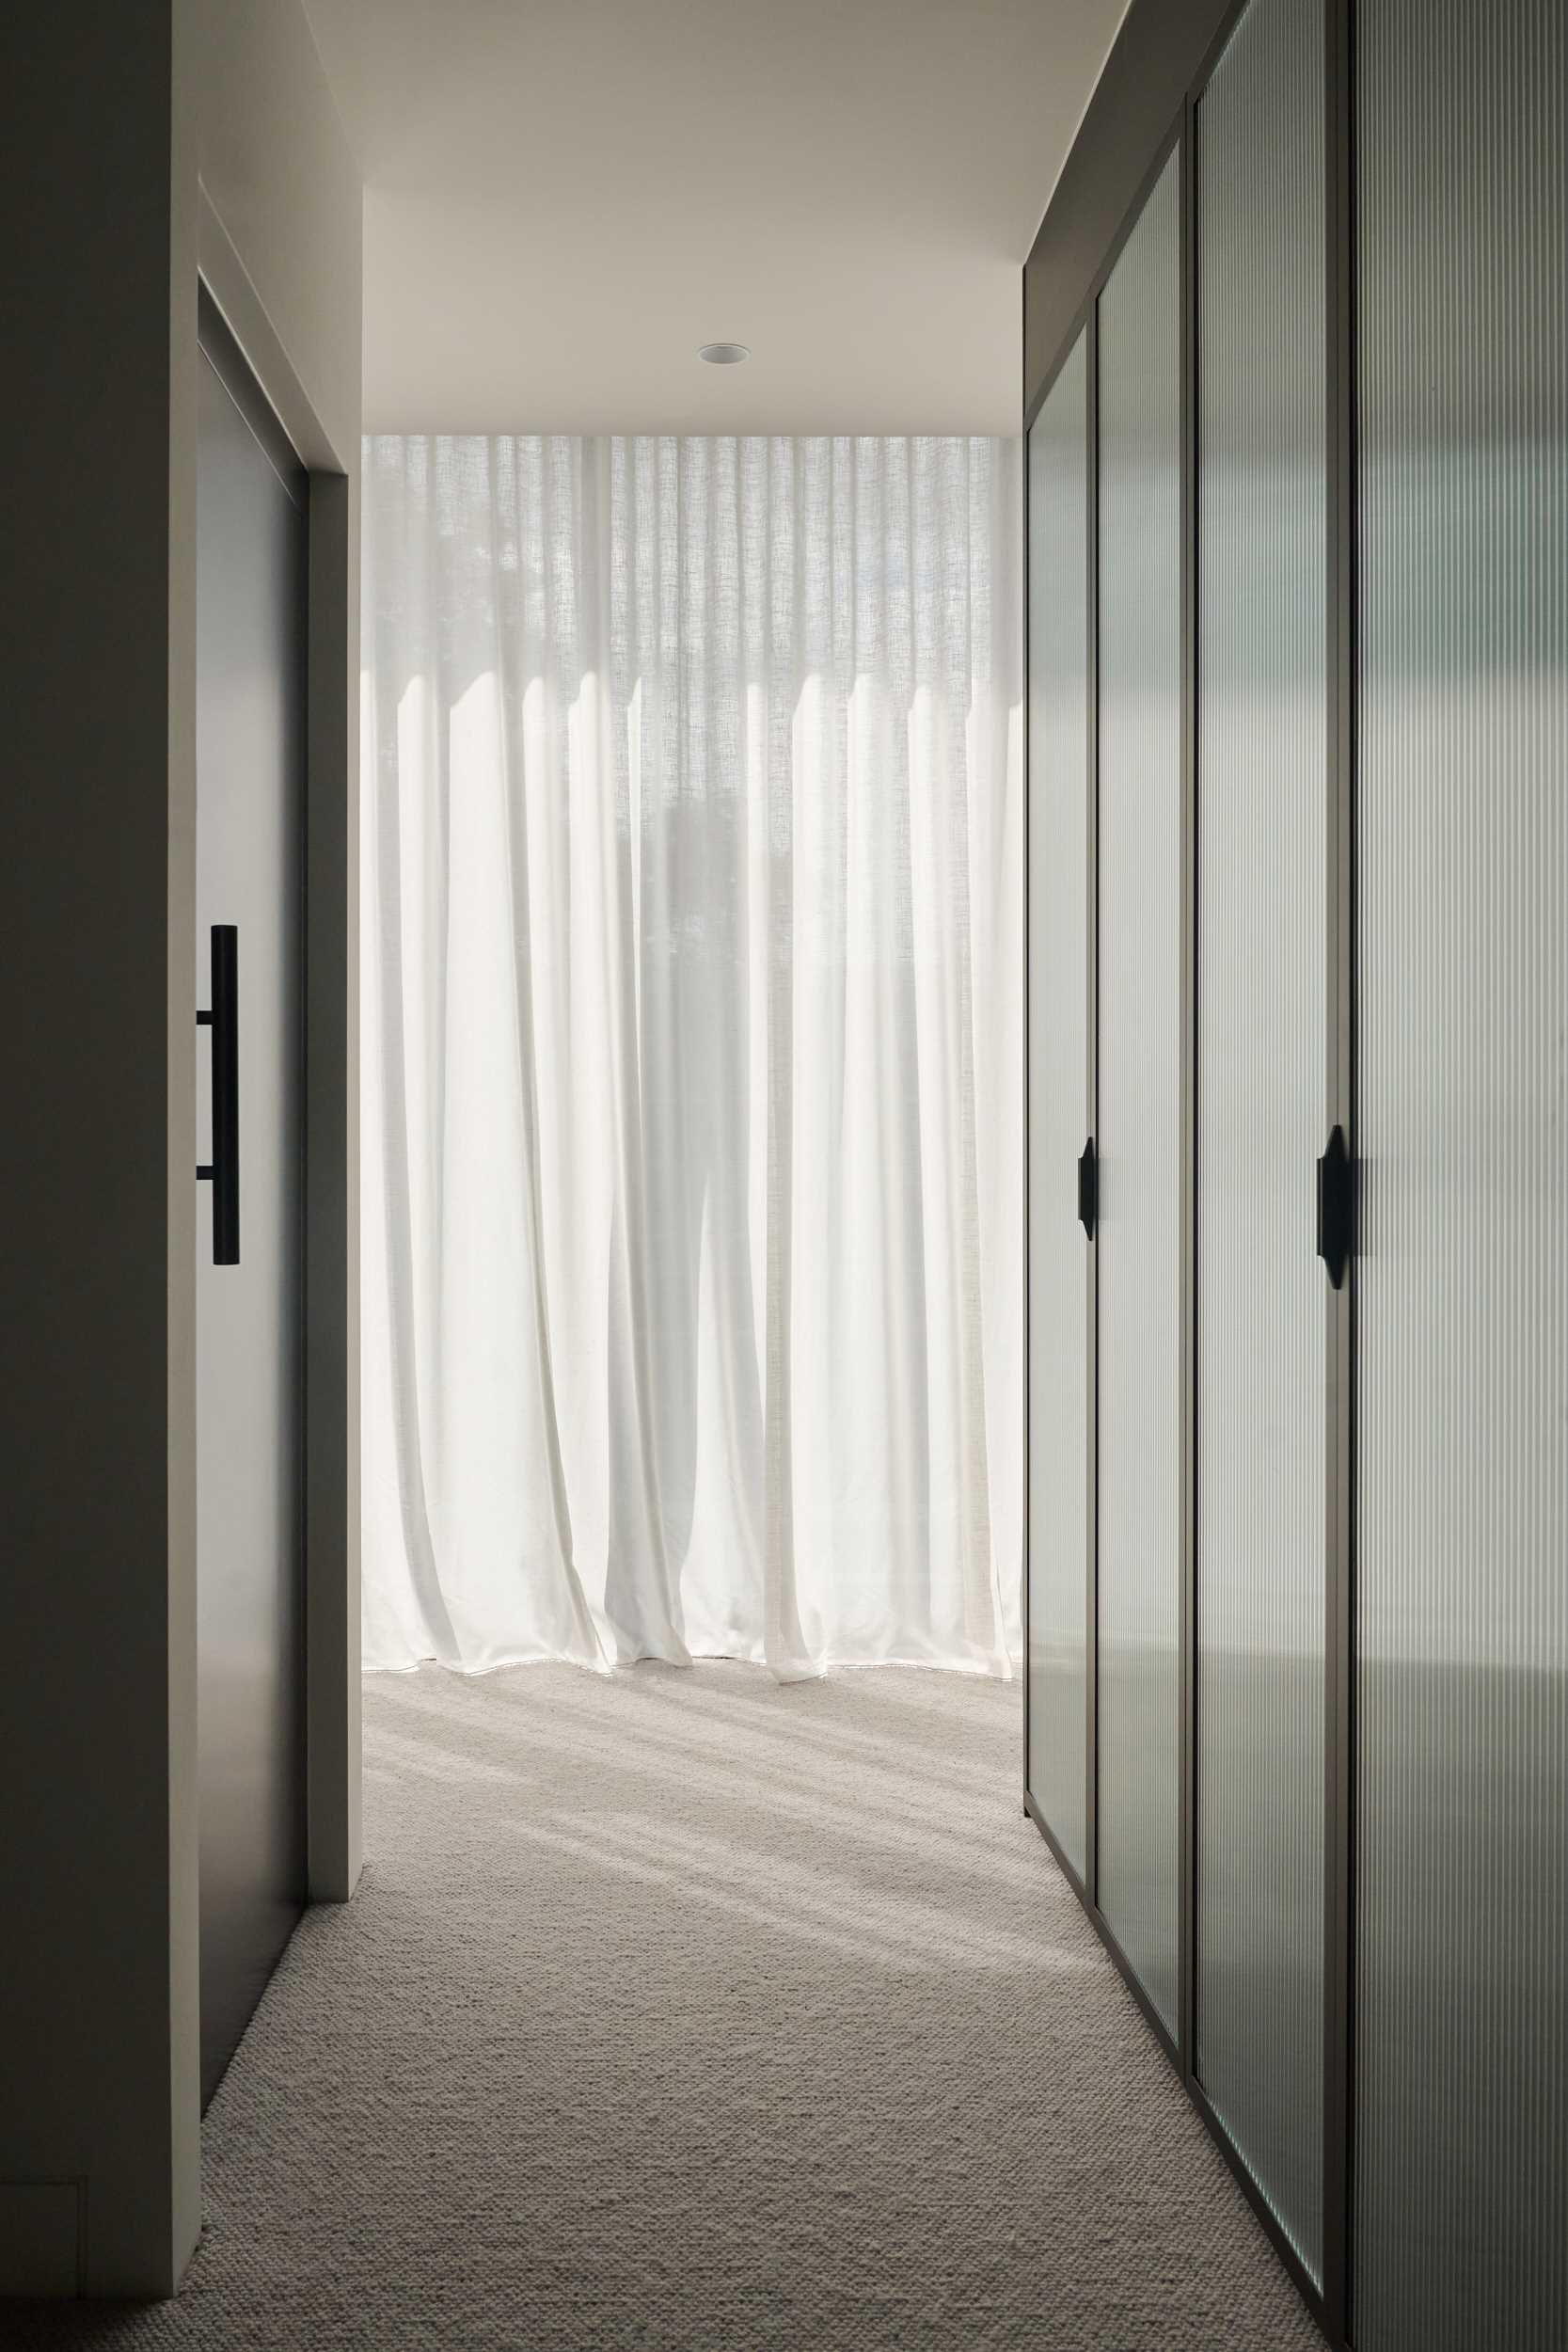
1196,0 -> 1328,2277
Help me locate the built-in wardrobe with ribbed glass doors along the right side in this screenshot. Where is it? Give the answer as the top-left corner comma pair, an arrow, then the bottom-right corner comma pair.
1025,0 -> 1568,2352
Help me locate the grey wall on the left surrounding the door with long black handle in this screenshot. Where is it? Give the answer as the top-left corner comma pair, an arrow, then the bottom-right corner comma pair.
0,0 -> 359,2294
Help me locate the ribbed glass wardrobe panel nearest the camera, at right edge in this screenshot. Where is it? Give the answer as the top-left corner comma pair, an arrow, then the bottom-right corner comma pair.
1354,0 -> 1568,2352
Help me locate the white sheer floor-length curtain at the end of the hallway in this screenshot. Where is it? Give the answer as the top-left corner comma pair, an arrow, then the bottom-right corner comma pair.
362,437 -> 1022,1675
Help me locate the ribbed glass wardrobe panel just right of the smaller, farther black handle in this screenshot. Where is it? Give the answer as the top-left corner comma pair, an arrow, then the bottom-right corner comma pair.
1096,155 -> 1182,2030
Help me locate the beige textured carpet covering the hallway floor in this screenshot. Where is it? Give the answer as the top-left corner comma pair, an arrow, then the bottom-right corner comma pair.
18,1665 -> 1319,2352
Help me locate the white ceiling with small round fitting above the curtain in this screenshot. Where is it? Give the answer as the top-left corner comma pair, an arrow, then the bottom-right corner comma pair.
306,0 -> 1126,433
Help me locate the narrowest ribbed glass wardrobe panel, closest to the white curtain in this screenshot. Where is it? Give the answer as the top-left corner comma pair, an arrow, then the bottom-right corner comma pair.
1030,337 -> 1088,1875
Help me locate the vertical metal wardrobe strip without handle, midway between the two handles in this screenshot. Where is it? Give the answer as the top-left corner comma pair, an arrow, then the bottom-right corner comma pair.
1176,94 -> 1199,2079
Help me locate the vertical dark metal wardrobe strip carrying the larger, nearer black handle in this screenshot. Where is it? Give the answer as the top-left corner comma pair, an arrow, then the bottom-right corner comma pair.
1323,0 -> 1356,2343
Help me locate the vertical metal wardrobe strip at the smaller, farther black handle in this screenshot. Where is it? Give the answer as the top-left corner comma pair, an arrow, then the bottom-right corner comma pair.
1084,294 -> 1101,1903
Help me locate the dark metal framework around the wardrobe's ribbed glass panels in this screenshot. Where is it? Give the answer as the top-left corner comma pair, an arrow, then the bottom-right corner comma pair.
1025,0 -> 1356,2347
